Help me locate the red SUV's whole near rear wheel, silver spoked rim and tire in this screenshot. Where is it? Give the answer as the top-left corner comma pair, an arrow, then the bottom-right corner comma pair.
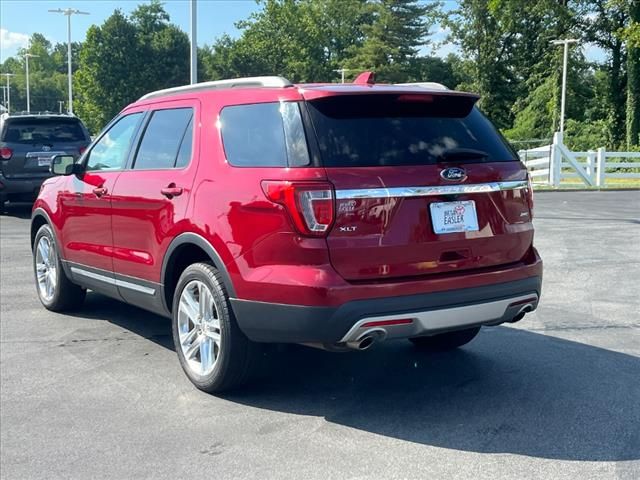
172,263 -> 257,393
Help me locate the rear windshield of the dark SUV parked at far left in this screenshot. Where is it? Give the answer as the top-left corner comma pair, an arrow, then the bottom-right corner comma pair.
2,118 -> 88,144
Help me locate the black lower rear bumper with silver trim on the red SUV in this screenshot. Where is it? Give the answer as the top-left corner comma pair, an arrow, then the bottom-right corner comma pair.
231,276 -> 542,345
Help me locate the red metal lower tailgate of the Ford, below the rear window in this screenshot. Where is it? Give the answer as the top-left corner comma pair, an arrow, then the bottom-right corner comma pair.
327,162 -> 533,280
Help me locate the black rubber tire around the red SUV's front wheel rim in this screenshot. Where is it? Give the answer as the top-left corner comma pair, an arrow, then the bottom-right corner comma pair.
33,225 -> 87,312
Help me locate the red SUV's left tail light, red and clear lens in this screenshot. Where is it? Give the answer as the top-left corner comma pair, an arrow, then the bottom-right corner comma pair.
262,180 -> 335,237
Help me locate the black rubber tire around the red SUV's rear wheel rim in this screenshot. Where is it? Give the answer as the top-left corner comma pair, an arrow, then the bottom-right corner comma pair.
172,263 -> 258,393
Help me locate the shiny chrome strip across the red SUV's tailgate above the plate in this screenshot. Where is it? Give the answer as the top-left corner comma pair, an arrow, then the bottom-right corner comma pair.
336,180 -> 527,200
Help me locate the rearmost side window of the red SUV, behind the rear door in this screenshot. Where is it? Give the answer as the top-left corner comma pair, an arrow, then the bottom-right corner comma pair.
220,102 -> 309,167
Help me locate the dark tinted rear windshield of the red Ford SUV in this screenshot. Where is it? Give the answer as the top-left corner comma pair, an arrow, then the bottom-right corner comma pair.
307,94 -> 517,167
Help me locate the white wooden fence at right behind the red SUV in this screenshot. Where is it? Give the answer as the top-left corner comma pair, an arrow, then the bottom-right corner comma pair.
518,133 -> 640,187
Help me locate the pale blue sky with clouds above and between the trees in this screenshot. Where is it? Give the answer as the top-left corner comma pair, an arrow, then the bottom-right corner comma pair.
0,0 -> 604,63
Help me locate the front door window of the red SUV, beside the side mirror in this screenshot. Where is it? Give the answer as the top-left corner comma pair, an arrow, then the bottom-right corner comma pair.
86,113 -> 142,171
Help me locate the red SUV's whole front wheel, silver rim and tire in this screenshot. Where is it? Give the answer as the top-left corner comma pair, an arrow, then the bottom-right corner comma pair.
33,225 -> 87,312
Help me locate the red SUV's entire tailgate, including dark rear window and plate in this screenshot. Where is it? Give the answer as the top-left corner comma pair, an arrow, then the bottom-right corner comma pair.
308,95 -> 533,281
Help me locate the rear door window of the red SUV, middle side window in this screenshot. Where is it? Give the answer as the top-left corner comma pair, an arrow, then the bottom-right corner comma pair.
133,108 -> 193,170
